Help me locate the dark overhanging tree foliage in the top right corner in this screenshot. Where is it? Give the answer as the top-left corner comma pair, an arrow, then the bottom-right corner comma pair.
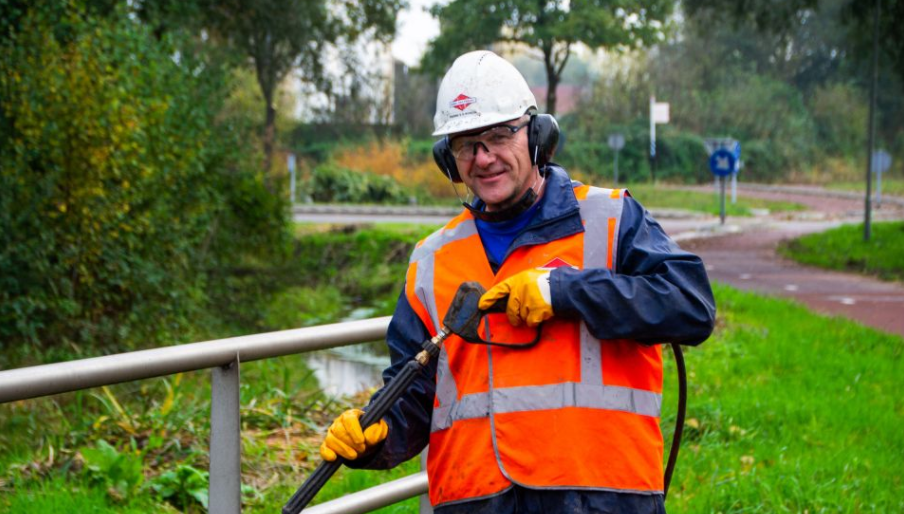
684,0 -> 904,162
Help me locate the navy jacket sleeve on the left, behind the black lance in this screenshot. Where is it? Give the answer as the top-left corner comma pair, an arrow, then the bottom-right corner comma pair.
348,287 -> 436,469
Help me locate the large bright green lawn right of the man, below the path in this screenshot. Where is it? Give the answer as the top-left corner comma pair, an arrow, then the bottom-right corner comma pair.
663,285 -> 904,513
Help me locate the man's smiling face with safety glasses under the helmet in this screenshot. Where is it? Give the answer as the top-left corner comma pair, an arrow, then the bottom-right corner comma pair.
449,117 -> 539,211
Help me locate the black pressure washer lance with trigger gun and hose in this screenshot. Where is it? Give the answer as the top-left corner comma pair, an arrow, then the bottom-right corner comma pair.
282,282 -> 687,514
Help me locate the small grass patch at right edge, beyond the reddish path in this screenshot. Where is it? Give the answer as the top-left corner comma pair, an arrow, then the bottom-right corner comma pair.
779,221 -> 904,280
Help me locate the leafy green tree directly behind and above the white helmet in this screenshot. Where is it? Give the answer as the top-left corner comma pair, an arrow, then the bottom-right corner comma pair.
422,0 -> 673,114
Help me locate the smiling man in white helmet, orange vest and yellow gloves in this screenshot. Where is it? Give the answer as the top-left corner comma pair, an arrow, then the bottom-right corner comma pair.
321,51 -> 715,514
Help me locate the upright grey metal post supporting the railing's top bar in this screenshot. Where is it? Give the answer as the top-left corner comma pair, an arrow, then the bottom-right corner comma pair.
208,355 -> 242,514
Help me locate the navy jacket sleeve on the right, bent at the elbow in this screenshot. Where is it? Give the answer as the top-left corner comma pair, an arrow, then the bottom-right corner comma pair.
550,196 -> 716,345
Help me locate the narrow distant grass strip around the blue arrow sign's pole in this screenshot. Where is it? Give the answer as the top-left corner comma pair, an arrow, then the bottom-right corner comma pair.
628,184 -> 804,216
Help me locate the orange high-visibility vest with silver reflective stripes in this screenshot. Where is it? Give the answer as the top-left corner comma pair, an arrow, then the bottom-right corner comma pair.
406,186 -> 663,506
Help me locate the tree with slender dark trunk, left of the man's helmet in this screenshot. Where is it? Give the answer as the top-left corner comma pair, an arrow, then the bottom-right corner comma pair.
200,0 -> 404,180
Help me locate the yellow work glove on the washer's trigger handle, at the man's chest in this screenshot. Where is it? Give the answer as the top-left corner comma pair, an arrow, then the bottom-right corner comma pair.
478,268 -> 553,327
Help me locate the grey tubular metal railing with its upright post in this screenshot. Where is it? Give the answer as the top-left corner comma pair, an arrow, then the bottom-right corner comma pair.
0,316 -> 427,514
